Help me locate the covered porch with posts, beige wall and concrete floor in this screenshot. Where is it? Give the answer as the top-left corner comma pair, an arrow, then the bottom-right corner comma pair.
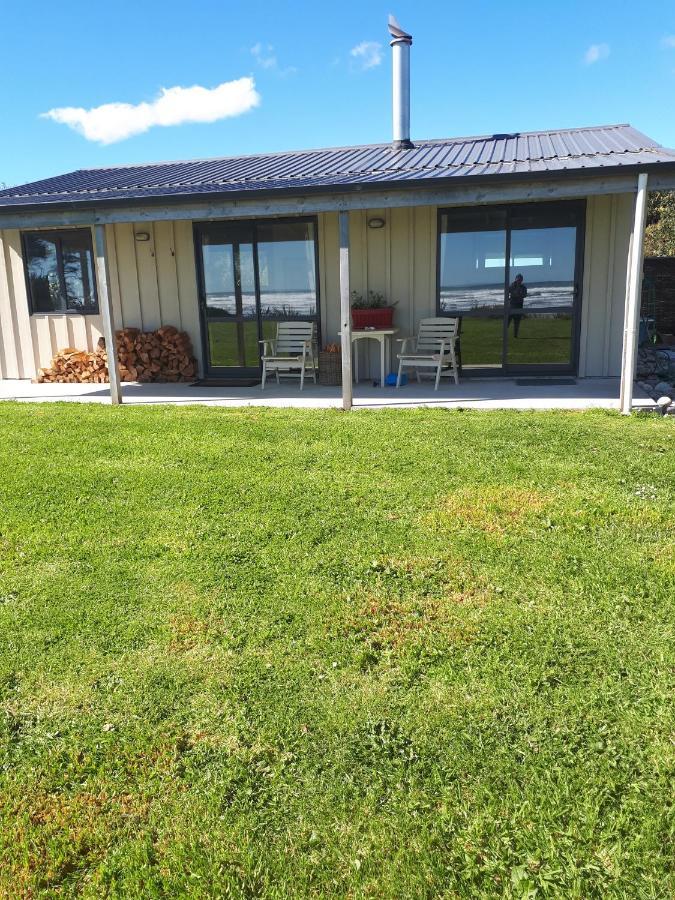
0,136 -> 675,413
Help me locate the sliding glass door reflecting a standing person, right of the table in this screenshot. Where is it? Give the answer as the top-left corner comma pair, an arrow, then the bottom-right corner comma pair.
438,202 -> 584,374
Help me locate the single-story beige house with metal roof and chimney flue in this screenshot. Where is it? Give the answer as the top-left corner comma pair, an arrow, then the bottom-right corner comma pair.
0,19 -> 675,407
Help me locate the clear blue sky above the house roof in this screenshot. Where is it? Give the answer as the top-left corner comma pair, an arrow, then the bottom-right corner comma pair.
0,0 -> 675,185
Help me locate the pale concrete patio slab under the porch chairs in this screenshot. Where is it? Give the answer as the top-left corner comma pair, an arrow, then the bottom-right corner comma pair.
0,378 -> 654,409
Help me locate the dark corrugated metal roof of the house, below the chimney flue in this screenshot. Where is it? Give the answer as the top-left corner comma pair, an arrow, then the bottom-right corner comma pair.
0,125 -> 675,208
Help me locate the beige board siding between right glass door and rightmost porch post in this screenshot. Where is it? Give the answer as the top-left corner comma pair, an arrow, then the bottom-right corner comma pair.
579,194 -> 634,377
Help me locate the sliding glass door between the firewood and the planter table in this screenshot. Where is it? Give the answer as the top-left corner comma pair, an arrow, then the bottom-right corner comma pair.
195,219 -> 319,379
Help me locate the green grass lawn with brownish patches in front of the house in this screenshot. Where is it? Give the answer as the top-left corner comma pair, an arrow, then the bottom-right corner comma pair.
0,403 -> 675,900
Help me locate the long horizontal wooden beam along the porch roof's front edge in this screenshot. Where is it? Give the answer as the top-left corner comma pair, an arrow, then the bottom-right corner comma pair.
0,172 -> 675,228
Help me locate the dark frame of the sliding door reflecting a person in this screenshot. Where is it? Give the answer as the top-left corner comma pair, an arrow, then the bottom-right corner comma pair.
436,198 -> 587,378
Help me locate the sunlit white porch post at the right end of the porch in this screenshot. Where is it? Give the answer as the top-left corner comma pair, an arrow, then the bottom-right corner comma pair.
620,172 -> 649,416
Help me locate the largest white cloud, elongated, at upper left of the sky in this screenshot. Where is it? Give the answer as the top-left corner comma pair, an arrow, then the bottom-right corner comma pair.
42,78 -> 260,144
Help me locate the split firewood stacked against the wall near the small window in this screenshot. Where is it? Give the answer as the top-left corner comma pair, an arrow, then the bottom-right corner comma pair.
35,325 -> 197,384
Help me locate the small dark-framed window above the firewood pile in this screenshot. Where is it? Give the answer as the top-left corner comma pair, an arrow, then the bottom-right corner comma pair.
23,229 -> 98,313
